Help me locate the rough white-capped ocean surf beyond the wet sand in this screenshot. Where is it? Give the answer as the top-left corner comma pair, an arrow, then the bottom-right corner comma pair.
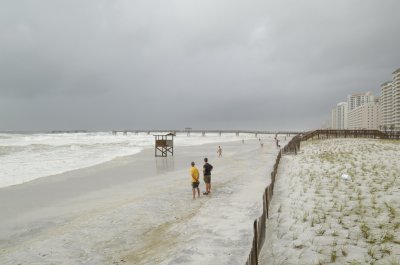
0,132 -> 250,188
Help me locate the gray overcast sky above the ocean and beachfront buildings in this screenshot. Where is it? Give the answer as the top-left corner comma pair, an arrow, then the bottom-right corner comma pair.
0,0 -> 400,130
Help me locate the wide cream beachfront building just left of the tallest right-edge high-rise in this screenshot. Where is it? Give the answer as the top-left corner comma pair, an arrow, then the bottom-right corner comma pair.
348,99 -> 380,130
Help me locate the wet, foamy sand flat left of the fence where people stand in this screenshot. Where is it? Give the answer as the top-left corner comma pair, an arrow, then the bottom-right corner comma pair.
0,136 -> 278,265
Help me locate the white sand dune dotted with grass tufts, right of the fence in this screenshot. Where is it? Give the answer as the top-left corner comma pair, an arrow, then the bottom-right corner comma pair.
260,139 -> 400,264
